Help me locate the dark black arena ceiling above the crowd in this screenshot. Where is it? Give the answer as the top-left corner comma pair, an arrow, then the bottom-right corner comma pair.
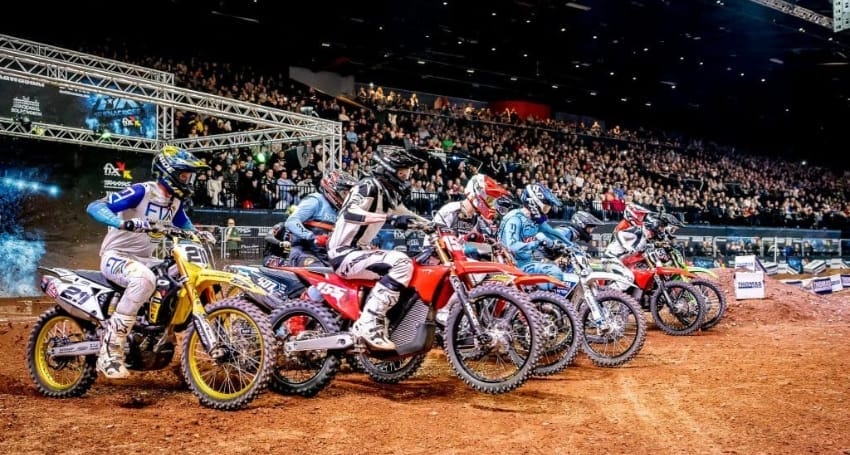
4,0 -> 850,164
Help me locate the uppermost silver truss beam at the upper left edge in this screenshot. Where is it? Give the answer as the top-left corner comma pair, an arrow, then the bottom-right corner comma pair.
0,34 -> 174,85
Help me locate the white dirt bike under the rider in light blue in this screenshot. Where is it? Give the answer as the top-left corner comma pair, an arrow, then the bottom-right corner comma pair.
510,242 -> 646,367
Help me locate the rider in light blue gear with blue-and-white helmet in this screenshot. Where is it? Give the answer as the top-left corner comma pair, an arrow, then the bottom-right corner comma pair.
499,183 -> 572,279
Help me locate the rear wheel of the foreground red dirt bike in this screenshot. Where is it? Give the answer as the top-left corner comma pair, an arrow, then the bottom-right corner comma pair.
269,300 -> 342,397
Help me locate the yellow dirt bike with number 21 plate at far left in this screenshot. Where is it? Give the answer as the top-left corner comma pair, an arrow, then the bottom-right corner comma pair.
27,228 -> 275,410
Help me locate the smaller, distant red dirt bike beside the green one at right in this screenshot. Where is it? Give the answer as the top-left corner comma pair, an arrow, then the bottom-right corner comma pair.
609,249 -> 706,336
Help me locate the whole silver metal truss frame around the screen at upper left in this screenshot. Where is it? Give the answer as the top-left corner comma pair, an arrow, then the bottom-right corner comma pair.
0,35 -> 342,170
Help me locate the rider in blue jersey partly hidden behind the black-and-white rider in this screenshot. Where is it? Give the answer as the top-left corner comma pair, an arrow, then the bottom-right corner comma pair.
263,170 -> 357,267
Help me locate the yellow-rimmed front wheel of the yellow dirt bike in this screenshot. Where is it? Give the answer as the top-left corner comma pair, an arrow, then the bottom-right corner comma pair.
181,298 -> 275,410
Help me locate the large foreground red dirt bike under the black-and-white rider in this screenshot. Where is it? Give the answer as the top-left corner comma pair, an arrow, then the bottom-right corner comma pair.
264,226 -> 543,396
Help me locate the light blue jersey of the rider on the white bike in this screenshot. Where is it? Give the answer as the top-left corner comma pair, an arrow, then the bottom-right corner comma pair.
499,209 -> 572,268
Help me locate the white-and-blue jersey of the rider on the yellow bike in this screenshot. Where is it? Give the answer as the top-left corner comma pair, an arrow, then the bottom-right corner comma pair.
86,182 -> 195,257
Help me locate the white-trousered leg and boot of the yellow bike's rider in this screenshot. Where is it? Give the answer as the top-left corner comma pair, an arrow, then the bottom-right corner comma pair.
97,251 -> 156,379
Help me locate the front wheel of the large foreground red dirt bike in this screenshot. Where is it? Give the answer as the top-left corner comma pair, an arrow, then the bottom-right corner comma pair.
444,284 -> 543,394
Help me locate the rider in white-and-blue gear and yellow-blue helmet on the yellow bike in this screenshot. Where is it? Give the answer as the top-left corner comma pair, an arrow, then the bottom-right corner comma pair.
86,146 -> 214,379
